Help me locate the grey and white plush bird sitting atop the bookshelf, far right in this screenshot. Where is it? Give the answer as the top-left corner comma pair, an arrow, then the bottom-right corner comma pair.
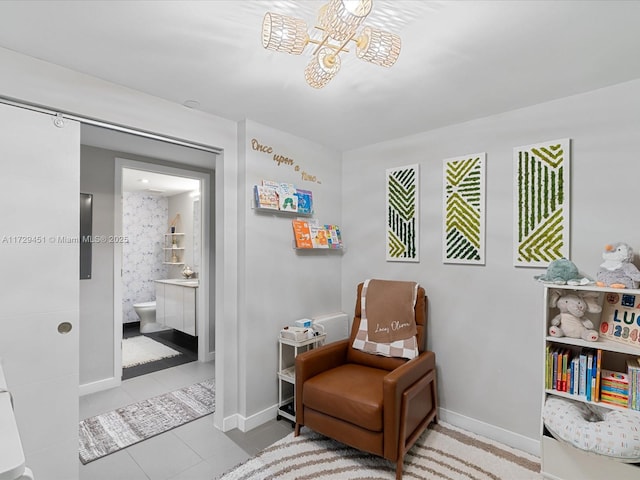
596,243 -> 640,288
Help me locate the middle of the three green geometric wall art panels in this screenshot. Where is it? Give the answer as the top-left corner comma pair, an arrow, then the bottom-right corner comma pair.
442,153 -> 486,265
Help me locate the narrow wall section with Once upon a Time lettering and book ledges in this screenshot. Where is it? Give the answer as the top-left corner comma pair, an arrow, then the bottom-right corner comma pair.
239,121 -> 350,428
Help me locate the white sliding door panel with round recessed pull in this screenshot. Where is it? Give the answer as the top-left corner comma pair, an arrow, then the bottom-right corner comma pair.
0,104 -> 80,480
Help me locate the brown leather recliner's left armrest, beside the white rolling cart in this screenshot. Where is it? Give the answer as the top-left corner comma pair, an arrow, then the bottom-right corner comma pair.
295,339 -> 349,425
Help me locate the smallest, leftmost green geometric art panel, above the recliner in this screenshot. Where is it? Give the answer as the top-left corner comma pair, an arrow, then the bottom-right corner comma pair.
386,164 -> 420,262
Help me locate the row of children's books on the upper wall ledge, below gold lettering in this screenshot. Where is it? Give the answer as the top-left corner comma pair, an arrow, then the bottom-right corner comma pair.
253,180 -> 313,215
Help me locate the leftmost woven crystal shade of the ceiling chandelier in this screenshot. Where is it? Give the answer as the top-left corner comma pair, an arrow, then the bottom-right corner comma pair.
262,12 -> 309,55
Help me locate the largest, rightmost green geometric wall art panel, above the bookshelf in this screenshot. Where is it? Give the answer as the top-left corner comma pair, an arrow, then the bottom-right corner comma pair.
513,138 -> 571,267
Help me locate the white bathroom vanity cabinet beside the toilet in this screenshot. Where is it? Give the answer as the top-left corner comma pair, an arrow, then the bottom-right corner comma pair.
156,278 -> 199,336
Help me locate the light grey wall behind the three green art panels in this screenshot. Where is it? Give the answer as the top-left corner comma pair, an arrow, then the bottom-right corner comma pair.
342,80 -> 640,449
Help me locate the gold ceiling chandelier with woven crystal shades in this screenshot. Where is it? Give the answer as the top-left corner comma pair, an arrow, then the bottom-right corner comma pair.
262,0 -> 400,88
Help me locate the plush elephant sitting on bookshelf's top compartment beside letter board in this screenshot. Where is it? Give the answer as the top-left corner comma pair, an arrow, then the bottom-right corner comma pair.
549,290 -> 602,342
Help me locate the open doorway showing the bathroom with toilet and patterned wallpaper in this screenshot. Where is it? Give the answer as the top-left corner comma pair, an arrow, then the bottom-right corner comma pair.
114,158 -> 211,380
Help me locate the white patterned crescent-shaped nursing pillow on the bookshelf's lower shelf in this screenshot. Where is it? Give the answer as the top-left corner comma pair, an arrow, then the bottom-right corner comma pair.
542,395 -> 640,463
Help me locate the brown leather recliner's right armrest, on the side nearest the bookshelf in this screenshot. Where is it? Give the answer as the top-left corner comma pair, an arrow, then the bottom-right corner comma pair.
383,351 -> 436,458
